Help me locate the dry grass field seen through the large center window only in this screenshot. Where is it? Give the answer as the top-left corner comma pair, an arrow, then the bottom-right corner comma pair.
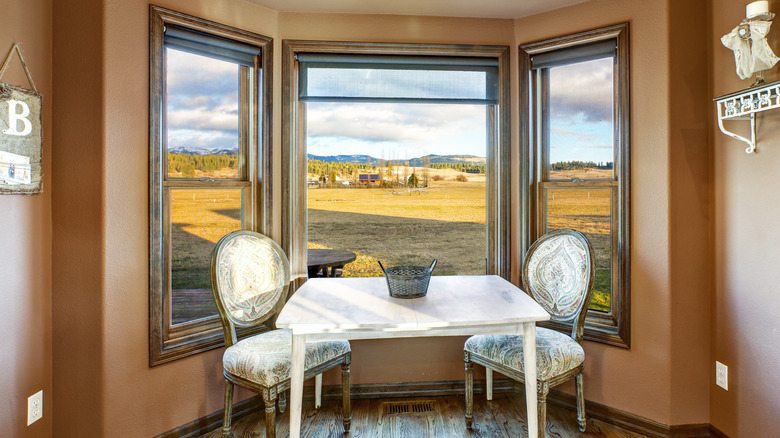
308,181 -> 485,276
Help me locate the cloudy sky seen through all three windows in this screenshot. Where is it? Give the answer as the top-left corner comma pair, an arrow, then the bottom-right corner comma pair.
167,49 -> 612,162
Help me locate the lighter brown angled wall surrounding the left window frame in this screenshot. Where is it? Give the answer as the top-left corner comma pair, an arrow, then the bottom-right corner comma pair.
100,0 -> 276,437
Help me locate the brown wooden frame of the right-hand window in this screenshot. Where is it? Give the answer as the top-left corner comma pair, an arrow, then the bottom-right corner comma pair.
518,23 -> 631,348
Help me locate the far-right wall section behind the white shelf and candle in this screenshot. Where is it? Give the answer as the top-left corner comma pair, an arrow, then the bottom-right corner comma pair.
709,0 -> 780,437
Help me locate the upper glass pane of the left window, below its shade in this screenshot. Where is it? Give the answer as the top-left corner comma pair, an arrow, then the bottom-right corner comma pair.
165,48 -> 240,178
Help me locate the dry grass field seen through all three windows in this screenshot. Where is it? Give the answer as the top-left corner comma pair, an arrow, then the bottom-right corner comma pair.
171,174 -> 610,323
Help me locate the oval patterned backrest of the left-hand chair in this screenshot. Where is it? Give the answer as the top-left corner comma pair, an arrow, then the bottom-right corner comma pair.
211,230 -> 290,327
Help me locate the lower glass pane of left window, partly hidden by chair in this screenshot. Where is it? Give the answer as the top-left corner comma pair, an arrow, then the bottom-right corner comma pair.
170,189 -> 243,324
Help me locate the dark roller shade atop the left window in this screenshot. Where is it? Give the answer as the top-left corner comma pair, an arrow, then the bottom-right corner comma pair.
163,25 -> 261,67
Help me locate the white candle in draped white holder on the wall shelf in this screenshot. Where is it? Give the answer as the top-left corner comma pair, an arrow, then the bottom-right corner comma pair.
720,0 -> 780,87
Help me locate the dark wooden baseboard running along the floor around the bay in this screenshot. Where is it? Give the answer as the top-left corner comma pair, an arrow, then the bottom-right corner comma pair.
160,379 -> 728,438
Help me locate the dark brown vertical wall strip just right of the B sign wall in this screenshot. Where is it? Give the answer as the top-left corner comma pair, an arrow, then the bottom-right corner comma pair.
52,0 -> 105,436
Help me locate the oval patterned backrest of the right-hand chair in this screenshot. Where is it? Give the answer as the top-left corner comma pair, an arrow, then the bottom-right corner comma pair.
523,229 -> 595,328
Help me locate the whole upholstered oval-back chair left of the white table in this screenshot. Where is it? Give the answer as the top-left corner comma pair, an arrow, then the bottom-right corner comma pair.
211,230 -> 351,438
